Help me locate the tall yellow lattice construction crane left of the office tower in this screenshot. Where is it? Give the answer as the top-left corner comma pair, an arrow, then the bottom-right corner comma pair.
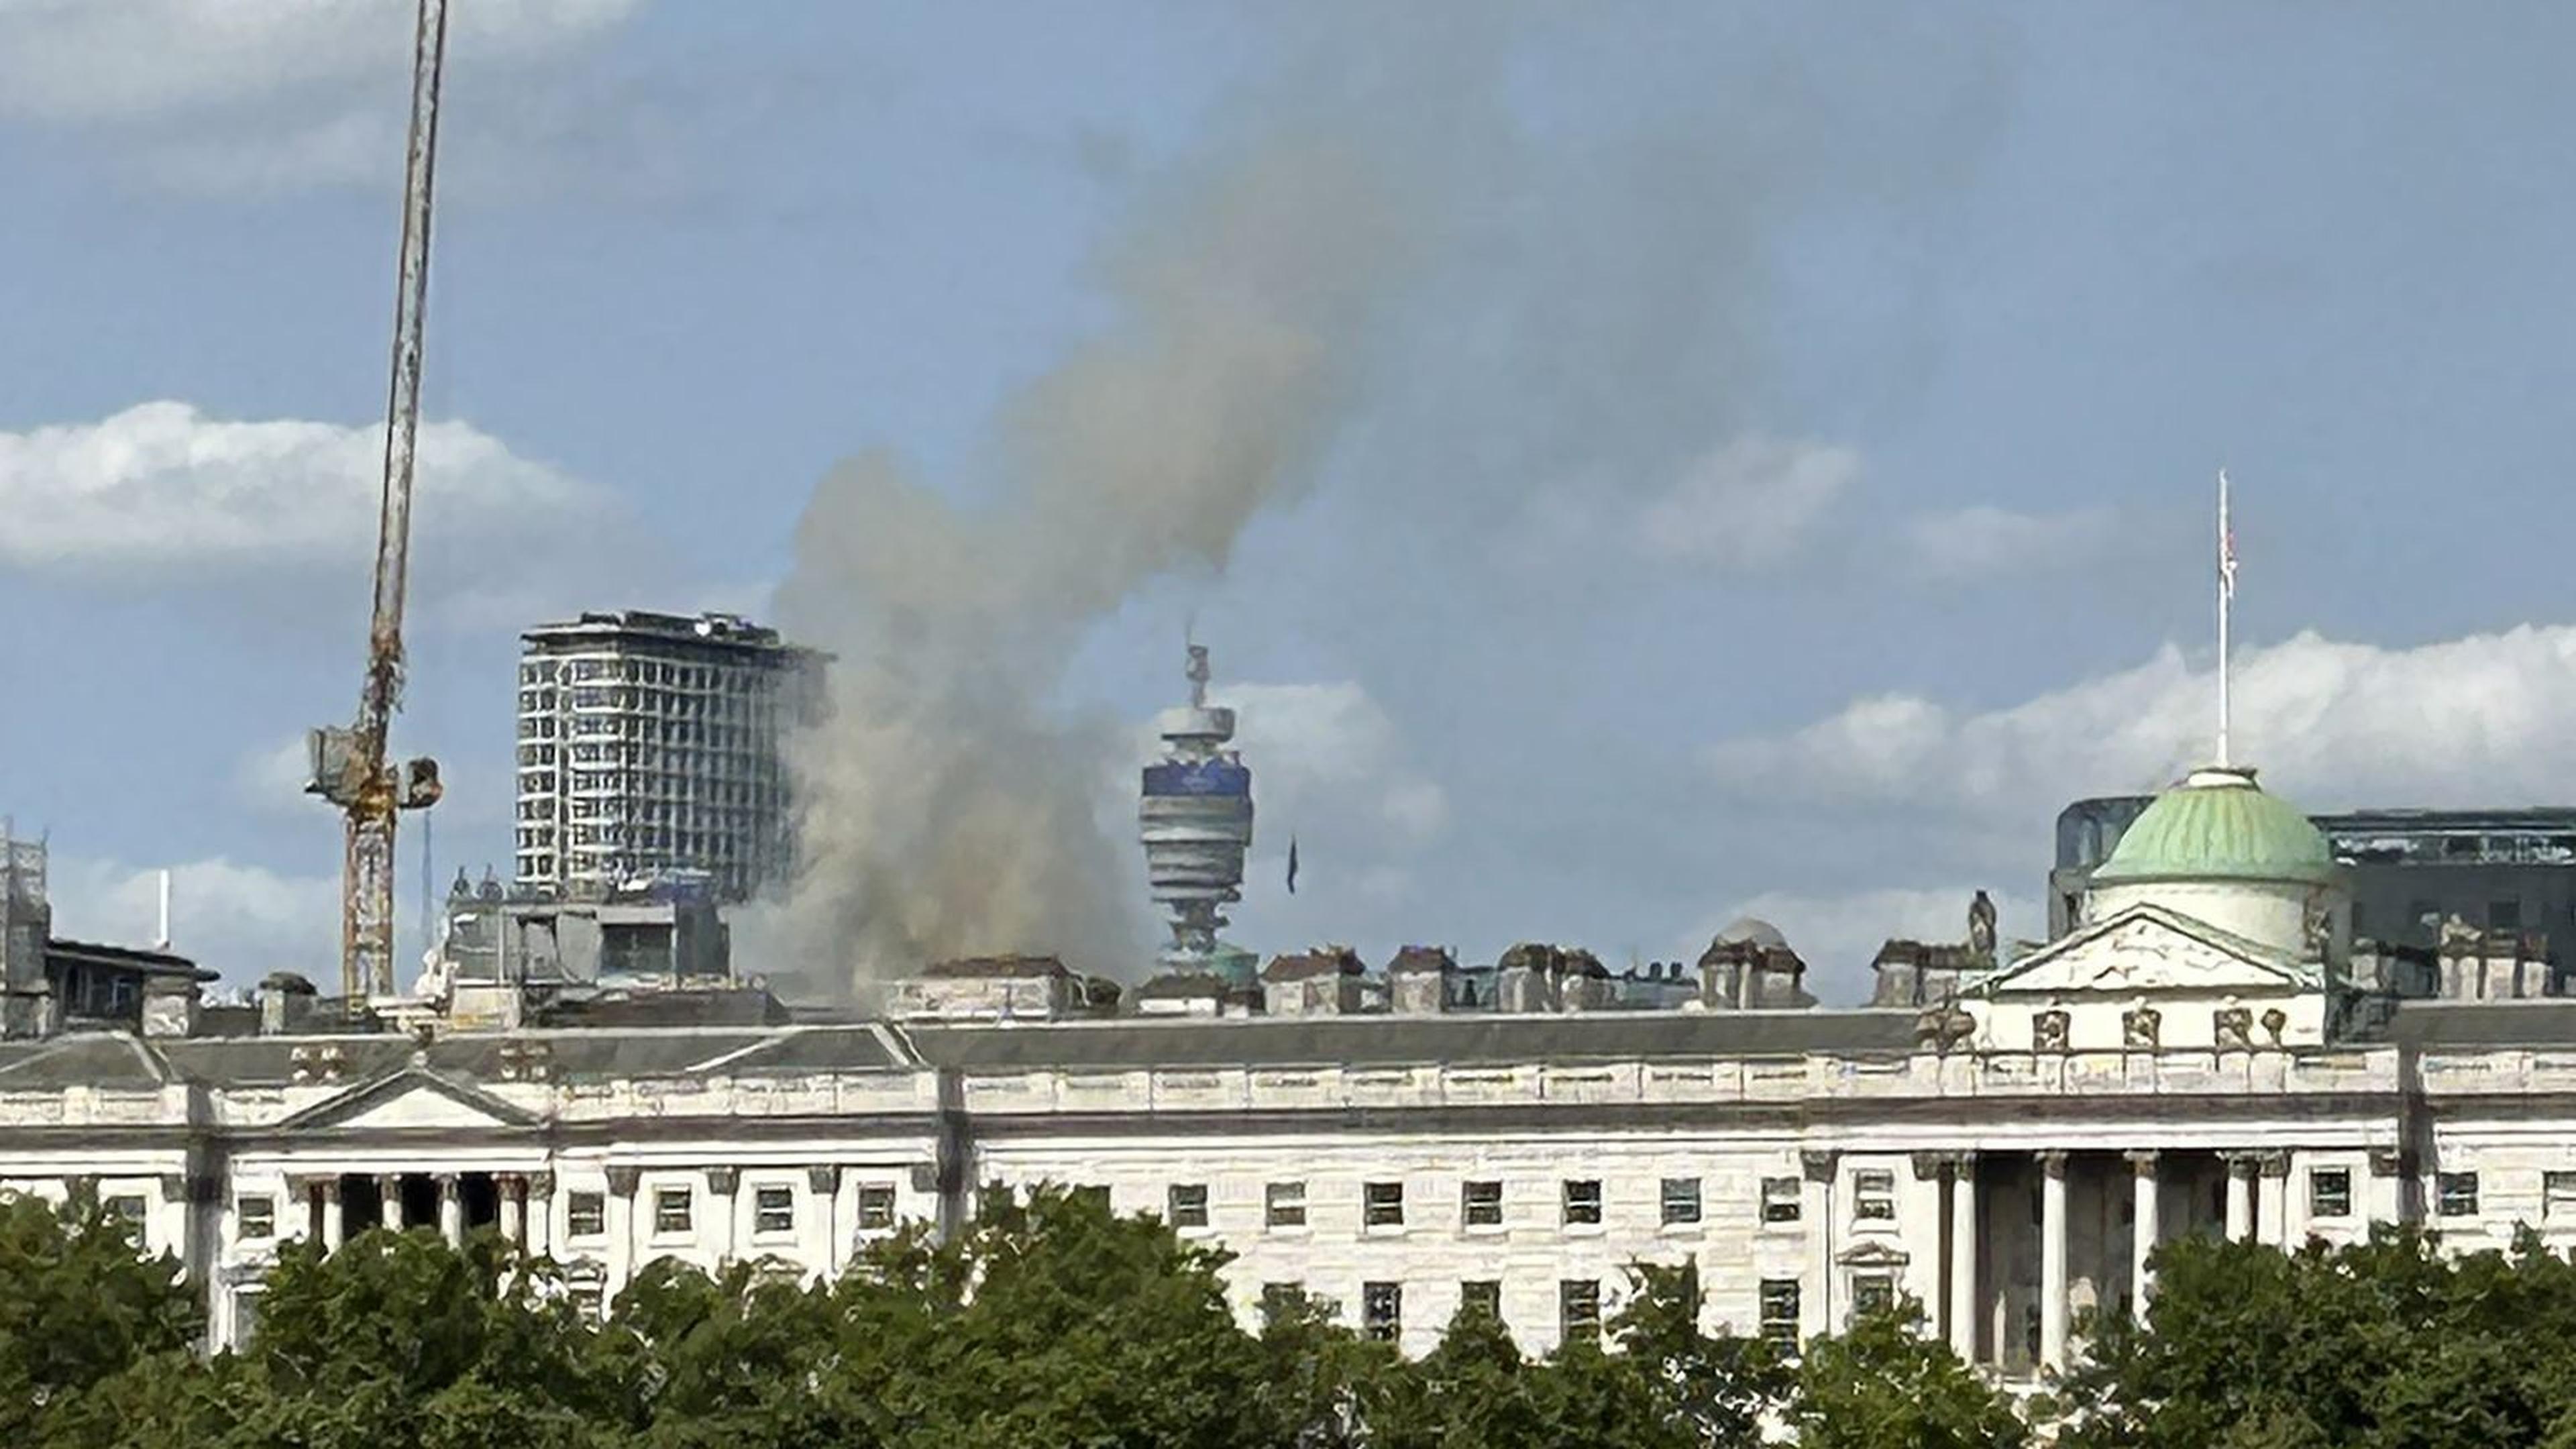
304,0 -> 448,1016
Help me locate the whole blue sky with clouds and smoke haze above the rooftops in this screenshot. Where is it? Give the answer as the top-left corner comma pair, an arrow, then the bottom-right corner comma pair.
0,0 -> 2576,996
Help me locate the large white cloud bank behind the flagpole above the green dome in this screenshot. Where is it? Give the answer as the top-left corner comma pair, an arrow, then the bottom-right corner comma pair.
1705,624 -> 2576,835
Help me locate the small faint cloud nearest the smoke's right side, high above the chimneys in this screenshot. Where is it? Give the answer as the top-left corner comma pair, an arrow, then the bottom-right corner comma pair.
1635,436 -> 1860,568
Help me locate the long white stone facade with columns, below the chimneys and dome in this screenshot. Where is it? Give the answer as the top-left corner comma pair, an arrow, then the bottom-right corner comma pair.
0,998 -> 2576,1372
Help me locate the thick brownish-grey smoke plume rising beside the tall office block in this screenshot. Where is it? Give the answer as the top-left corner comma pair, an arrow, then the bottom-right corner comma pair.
773,107 -> 1414,990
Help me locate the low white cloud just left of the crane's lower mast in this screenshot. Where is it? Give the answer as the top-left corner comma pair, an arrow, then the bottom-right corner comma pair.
46,856 -> 340,990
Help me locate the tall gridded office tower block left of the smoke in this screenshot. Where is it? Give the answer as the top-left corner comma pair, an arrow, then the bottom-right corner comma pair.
518,611 -> 824,900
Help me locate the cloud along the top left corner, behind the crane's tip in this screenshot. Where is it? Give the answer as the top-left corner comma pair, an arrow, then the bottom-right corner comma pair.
0,0 -> 641,121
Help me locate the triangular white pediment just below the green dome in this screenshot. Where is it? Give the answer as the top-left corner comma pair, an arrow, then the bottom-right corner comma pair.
1968,905 -> 2316,996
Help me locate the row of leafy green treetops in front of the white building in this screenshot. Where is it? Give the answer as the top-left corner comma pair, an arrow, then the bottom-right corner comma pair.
30,1189 -> 2576,1449
